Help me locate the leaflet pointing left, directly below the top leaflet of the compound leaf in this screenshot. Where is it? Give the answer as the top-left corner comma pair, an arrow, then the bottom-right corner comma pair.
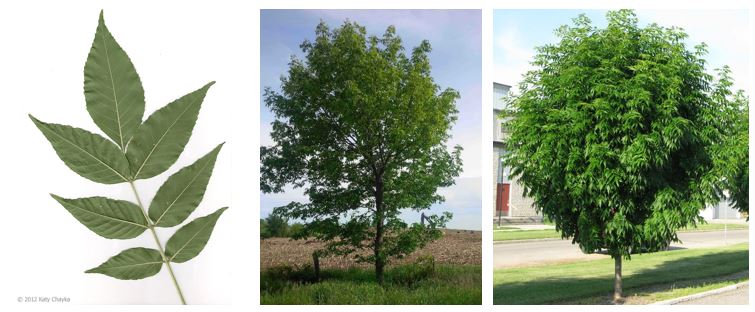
29,115 -> 131,184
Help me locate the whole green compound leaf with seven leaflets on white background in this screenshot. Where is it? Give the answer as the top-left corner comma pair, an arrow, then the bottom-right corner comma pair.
30,13 -> 226,303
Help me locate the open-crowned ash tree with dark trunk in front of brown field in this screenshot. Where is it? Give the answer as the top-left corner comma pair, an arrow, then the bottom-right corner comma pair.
260,21 -> 461,283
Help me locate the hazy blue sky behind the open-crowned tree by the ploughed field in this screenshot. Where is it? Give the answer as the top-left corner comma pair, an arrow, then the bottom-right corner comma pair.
260,10 -> 482,230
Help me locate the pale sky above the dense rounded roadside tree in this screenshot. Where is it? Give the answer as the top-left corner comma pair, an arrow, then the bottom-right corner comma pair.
493,10 -> 750,90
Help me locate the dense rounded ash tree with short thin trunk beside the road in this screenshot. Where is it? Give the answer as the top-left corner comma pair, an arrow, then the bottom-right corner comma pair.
503,10 -> 747,300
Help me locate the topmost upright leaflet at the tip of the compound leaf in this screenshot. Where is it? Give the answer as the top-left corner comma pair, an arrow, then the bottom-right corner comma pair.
84,12 -> 144,150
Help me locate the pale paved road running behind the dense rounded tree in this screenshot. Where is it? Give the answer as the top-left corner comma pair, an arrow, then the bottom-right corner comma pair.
493,230 -> 749,269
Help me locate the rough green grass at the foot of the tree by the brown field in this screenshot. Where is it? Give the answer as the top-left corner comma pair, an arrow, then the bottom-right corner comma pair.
260,265 -> 482,305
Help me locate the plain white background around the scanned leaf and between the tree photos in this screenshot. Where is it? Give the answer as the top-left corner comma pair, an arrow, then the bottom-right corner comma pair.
0,0 -> 755,311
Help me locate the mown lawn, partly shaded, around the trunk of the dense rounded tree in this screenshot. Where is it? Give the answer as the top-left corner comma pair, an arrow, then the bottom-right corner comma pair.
493,243 -> 749,304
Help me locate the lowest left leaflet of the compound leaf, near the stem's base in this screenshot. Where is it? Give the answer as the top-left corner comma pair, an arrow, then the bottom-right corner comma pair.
86,247 -> 163,280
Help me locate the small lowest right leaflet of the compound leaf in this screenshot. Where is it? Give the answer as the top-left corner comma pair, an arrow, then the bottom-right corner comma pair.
165,207 -> 228,263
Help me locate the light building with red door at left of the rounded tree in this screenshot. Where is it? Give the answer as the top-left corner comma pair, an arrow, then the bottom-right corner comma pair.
493,82 -> 542,223
